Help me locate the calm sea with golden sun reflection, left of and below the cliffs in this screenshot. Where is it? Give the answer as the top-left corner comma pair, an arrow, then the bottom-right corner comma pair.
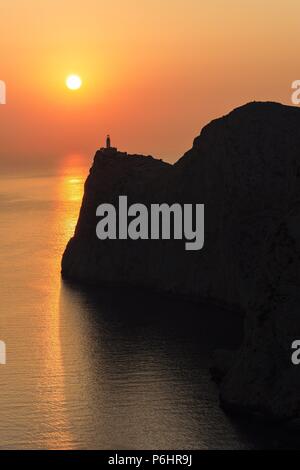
0,163 -> 298,450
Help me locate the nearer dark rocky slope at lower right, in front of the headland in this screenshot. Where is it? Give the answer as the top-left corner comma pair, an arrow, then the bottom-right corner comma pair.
221,206 -> 300,422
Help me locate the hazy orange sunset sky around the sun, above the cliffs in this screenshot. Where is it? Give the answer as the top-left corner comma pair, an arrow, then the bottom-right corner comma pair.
0,0 -> 300,169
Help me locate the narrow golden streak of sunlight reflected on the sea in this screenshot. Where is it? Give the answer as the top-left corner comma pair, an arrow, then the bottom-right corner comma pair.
35,155 -> 86,449
